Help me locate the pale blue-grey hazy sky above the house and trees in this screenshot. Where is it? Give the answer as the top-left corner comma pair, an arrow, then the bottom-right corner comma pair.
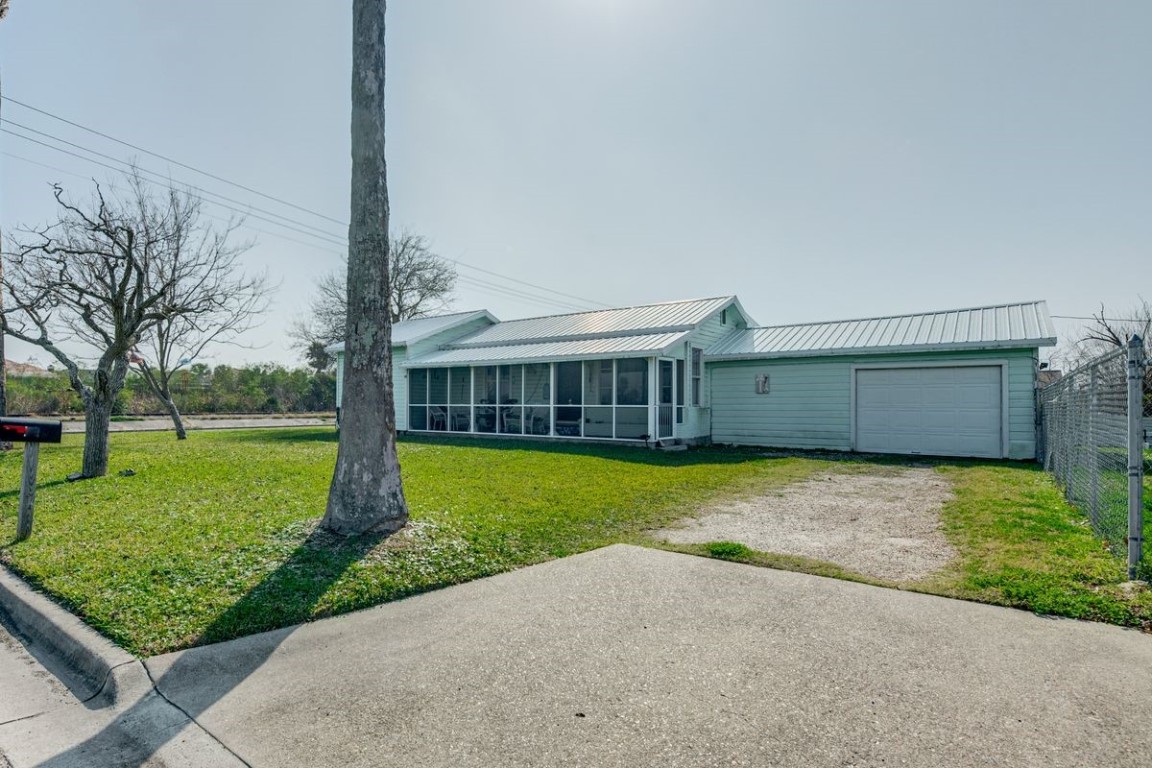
0,0 -> 1152,363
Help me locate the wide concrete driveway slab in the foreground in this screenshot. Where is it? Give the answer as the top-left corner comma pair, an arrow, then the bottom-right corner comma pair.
119,546 -> 1152,768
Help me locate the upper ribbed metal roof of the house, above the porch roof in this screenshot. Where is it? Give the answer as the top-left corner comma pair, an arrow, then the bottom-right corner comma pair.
444,296 -> 748,348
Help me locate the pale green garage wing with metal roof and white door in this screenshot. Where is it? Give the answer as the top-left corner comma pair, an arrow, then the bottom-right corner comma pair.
704,302 -> 1055,459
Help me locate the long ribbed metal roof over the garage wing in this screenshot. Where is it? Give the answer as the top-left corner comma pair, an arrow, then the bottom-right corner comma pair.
706,302 -> 1056,359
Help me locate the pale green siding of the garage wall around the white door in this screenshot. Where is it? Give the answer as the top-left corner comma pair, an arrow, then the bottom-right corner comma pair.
707,349 -> 1036,459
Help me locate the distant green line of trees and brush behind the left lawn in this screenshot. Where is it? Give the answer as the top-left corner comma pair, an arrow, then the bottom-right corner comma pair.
8,364 -> 336,417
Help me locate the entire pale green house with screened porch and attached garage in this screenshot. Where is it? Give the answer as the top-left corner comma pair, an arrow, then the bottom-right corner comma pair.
333,296 -> 1055,459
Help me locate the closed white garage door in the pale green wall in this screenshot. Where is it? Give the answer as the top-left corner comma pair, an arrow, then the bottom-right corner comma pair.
856,365 -> 1003,457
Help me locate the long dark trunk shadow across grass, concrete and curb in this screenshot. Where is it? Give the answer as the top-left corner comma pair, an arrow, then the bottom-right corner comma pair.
40,530 -> 387,768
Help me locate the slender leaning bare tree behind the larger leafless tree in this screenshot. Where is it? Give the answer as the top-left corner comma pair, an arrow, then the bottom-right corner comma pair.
129,218 -> 271,440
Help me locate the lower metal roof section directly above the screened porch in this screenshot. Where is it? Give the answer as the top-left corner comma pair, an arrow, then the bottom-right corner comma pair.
402,330 -> 690,367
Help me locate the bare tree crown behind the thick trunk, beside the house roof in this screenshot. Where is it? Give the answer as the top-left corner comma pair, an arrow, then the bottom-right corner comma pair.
288,231 -> 456,356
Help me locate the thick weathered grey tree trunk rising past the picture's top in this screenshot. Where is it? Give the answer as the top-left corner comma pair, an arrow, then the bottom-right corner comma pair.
321,0 -> 408,535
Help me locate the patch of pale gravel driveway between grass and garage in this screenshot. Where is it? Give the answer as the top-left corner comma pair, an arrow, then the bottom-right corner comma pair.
654,466 -> 955,581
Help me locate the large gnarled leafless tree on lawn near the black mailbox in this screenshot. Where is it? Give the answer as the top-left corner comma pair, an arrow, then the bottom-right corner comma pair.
0,173 -> 259,478
